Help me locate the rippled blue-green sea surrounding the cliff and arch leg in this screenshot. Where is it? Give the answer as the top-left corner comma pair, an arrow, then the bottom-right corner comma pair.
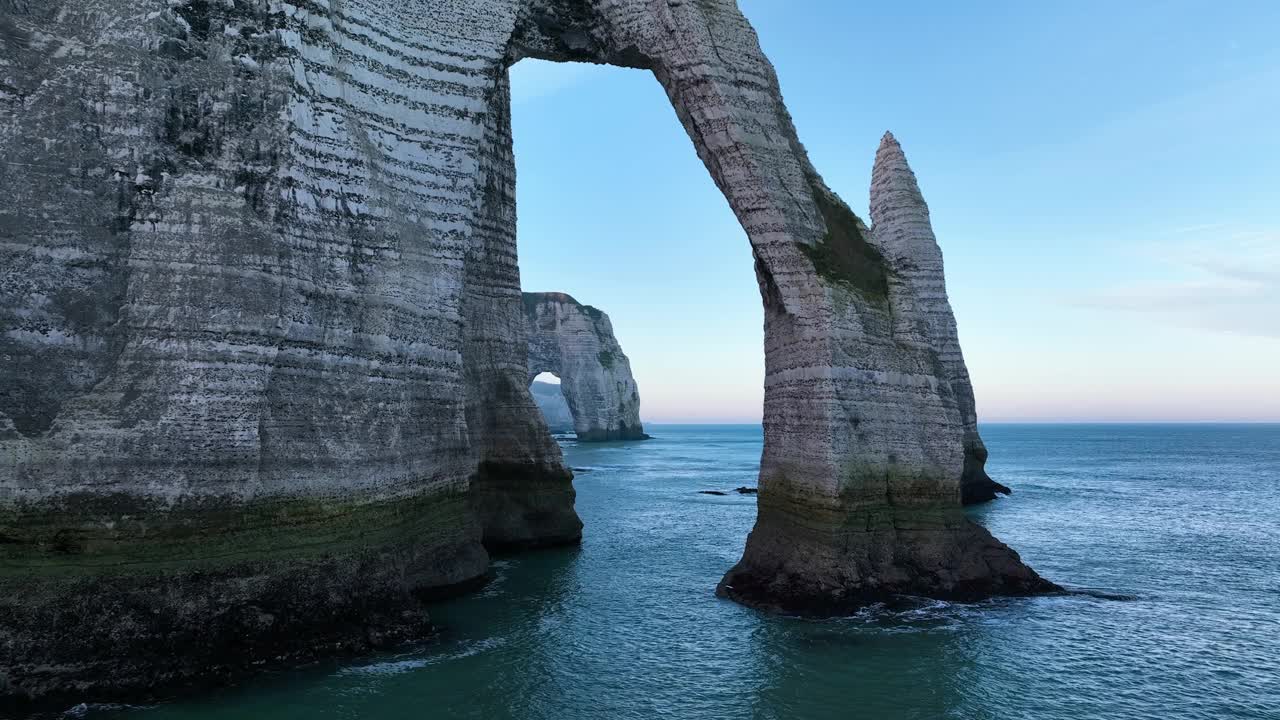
85,425 -> 1280,720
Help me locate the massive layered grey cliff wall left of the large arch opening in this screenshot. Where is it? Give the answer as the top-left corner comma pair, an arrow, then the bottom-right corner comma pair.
0,0 -> 581,697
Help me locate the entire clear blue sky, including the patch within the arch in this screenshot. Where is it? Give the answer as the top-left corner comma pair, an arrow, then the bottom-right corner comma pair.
512,0 -> 1280,421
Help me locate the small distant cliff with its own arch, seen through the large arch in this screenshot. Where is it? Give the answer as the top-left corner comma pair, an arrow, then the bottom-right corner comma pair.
524,292 -> 649,442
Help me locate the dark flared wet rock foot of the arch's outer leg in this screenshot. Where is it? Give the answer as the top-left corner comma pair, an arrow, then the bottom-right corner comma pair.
716,509 -> 1064,618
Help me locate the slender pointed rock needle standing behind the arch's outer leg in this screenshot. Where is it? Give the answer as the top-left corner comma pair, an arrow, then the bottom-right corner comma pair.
870,133 -> 1010,505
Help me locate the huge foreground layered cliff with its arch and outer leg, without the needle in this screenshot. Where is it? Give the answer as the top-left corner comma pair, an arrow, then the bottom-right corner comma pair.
0,0 -> 1047,698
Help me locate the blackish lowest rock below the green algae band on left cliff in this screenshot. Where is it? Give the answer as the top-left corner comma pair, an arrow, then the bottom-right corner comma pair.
0,547 -> 484,708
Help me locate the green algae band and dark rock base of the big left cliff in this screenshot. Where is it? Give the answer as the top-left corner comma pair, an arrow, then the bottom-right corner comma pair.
0,493 -> 488,716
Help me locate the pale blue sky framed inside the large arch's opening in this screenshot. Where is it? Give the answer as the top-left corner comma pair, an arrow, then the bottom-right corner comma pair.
511,53 -> 764,433
